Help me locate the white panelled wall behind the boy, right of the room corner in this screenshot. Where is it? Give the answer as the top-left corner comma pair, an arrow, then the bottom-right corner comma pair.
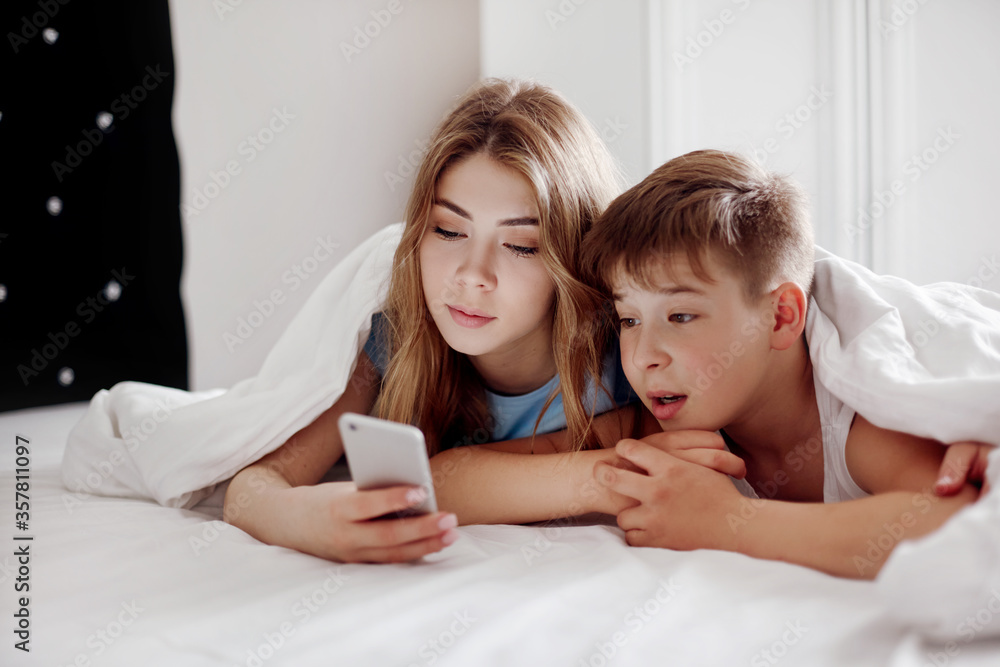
481,0 -> 1000,290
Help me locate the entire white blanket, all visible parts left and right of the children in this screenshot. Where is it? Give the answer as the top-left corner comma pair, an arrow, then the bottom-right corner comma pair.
62,232 -> 1000,638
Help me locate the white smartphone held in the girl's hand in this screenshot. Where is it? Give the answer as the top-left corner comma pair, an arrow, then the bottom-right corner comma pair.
337,412 -> 437,518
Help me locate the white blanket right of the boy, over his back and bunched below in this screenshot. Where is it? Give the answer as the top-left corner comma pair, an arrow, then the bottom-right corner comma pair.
809,249 -> 1000,645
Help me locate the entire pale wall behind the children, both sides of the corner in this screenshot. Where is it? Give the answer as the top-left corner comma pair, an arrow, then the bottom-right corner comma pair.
171,0 -> 1000,388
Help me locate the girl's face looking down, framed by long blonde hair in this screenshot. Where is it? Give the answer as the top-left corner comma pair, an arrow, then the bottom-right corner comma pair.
420,153 -> 555,386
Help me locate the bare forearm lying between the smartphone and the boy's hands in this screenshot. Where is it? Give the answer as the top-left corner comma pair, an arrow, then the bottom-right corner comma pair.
431,446 -> 614,525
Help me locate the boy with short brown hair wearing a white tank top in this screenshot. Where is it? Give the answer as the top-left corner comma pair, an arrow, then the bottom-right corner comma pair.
582,151 -> 978,578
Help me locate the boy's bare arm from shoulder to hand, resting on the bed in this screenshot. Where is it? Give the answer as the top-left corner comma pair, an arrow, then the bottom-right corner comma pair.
597,416 -> 977,578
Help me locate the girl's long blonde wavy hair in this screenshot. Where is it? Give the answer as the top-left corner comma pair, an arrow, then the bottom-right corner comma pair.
376,79 -> 621,454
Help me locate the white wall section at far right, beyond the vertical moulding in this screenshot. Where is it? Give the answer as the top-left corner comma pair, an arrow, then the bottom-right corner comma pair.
872,0 -> 1000,291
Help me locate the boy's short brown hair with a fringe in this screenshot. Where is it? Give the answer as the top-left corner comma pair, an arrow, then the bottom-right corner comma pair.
582,150 -> 814,301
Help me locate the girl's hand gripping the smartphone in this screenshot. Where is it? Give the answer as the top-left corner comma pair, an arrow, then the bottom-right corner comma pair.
280,482 -> 458,563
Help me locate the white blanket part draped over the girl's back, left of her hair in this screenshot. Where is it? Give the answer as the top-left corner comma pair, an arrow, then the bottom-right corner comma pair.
62,223 -> 403,508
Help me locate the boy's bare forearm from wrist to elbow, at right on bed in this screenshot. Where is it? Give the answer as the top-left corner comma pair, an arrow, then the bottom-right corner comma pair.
728,486 -> 977,579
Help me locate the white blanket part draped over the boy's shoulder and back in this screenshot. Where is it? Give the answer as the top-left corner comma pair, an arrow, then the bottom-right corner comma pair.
809,248 -> 1000,445
